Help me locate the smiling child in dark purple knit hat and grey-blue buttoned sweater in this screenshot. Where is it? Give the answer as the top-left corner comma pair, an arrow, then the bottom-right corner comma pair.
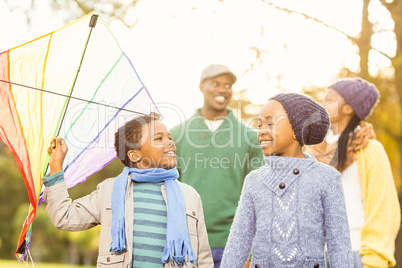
221,93 -> 353,268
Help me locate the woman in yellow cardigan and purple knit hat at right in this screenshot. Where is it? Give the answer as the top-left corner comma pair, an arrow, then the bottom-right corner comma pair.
309,78 -> 401,268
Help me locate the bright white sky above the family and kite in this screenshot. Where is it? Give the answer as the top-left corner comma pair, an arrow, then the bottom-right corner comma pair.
0,0 -> 396,128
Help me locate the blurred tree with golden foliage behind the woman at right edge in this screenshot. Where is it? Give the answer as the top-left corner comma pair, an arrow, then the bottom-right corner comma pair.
250,0 -> 402,191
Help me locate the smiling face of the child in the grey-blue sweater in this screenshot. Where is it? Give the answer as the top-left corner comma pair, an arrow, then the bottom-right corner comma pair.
258,100 -> 304,157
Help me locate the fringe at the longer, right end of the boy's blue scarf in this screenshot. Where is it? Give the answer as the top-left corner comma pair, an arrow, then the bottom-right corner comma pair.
162,239 -> 196,267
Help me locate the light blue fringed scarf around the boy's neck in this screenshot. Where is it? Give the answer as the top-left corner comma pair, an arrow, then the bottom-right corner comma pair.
110,167 -> 196,266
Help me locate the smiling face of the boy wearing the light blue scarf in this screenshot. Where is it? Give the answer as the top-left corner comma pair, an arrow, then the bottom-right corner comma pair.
138,120 -> 177,169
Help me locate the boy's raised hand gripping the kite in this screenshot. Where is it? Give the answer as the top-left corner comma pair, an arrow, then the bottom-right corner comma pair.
47,137 -> 68,175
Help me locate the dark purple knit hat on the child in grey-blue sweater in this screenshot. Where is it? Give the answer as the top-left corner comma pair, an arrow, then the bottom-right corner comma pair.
271,93 -> 330,146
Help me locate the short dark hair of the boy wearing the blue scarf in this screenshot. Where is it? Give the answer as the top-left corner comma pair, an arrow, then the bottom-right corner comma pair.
114,115 -> 156,167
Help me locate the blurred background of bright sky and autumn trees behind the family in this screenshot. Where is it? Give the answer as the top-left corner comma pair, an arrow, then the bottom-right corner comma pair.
0,0 -> 402,267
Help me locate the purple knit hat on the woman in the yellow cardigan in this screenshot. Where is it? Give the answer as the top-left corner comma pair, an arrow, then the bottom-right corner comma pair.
329,78 -> 380,120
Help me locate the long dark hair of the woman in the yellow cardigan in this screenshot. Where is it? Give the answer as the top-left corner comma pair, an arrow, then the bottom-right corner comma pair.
330,115 -> 360,172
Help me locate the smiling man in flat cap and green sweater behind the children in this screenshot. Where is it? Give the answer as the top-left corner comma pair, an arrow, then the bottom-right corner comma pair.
170,64 -> 263,268
